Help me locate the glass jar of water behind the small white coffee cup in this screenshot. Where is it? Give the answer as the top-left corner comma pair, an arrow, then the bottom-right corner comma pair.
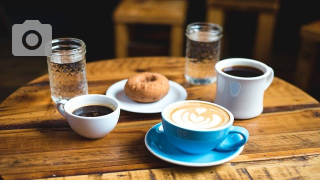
47,38 -> 88,103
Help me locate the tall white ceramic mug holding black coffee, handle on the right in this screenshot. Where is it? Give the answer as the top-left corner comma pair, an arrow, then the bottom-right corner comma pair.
214,58 -> 274,119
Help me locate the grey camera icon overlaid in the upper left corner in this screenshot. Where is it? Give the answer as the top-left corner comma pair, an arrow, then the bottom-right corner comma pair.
12,20 -> 52,56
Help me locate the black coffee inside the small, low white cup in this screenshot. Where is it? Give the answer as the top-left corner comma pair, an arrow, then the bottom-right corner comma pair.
72,105 -> 113,117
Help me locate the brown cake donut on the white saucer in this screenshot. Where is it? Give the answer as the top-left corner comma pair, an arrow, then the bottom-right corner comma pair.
124,72 -> 170,103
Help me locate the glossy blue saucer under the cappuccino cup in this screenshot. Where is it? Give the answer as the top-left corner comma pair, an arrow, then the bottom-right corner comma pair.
145,123 -> 243,167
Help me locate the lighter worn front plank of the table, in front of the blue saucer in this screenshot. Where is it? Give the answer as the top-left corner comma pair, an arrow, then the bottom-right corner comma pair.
36,155 -> 320,180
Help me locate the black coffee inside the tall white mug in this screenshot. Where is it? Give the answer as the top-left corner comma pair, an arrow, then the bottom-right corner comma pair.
222,66 -> 264,77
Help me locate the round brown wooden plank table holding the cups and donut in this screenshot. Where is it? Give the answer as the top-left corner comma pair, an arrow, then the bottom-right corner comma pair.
0,57 -> 320,179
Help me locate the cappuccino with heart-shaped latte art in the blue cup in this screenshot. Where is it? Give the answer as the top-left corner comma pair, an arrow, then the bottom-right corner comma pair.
167,102 -> 230,130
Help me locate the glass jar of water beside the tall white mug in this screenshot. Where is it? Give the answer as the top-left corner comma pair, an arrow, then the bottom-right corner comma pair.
184,22 -> 222,85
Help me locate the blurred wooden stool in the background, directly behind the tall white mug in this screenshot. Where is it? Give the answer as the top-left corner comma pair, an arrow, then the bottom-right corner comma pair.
206,0 -> 280,63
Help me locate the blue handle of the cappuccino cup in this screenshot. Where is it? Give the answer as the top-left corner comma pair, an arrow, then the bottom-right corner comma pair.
214,126 -> 249,151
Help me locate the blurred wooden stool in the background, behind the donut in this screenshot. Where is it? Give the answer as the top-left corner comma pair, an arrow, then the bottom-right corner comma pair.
113,0 -> 188,58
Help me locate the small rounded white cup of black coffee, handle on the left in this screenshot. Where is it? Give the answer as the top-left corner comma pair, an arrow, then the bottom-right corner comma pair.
57,94 -> 120,139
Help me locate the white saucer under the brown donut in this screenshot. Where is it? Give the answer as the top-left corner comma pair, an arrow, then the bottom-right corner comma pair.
106,79 -> 187,113
